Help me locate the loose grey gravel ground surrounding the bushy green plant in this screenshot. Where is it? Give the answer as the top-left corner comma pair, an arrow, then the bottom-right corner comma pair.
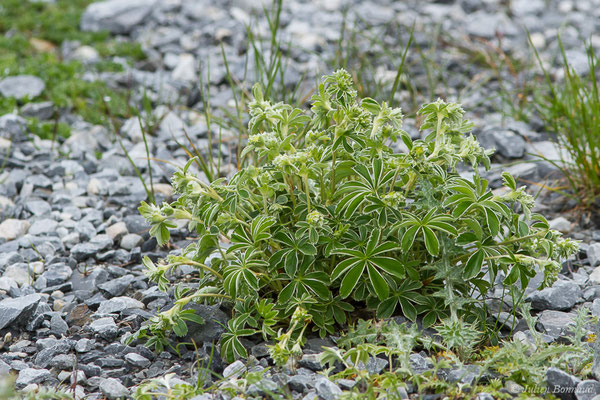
0,0 -> 600,400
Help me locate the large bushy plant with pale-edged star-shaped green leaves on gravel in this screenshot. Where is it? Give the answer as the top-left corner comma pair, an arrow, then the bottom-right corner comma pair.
132,70 -> 577,360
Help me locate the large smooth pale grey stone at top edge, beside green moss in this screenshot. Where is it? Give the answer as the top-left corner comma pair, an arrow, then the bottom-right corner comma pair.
81,0 -> 156,33
